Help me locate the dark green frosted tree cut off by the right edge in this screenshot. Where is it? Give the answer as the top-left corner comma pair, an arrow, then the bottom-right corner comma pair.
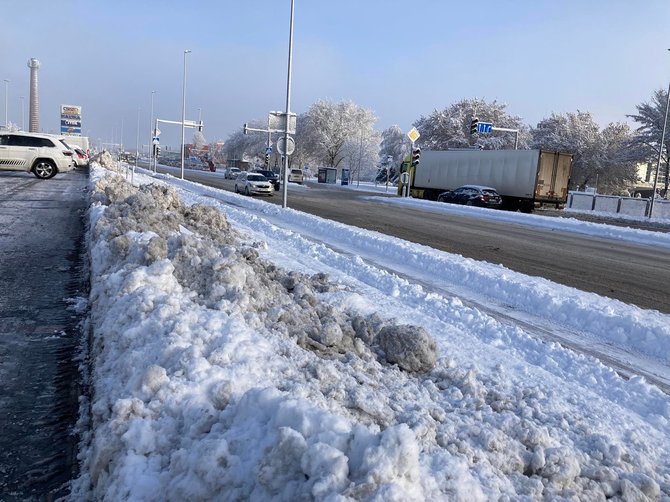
628,89 -> 670,193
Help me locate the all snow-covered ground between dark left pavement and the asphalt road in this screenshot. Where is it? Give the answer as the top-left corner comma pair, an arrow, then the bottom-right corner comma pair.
73,157 -> 670,501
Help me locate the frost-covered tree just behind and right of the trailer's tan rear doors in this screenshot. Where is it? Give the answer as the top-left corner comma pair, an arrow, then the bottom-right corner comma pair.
531,111 -> 636,192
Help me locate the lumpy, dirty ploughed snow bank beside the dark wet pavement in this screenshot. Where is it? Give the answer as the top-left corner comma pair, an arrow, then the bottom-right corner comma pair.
73,159 -> 670,501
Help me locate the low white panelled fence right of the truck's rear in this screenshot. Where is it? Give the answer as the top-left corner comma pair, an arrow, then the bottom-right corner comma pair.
567,192 -> 670,219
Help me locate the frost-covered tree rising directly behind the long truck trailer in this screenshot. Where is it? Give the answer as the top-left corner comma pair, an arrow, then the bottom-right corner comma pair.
414,98 -> 529,150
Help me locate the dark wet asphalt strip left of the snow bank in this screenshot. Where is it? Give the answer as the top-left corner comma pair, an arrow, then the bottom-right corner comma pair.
0,169 -> 88,501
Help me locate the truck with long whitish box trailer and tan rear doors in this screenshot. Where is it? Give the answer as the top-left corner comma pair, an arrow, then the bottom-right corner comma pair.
406,150 -> 572,212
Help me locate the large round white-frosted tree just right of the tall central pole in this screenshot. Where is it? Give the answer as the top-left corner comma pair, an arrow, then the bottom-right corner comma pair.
297,100 -> 379,168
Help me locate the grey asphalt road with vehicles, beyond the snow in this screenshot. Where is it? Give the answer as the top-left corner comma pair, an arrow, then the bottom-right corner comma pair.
148,166 -> 670,314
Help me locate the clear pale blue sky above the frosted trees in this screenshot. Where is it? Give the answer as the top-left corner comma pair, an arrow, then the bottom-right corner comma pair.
0,0 -> 670,149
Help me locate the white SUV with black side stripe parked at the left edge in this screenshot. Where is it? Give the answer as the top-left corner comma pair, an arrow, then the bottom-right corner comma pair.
0,131 -> 74,180
